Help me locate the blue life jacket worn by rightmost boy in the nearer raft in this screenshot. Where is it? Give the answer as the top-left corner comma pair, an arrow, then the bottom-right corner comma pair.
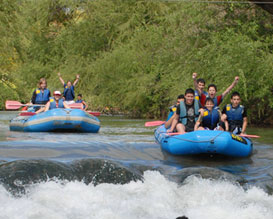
226,104 -> 244,127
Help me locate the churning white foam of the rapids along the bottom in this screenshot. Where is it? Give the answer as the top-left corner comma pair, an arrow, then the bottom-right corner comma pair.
0,171 -> 273,219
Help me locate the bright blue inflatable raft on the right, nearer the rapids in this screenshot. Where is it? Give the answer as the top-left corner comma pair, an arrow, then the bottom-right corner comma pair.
154,125 -> 253,157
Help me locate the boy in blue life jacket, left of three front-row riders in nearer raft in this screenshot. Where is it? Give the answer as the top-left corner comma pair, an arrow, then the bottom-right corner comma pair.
167,88 -> 202,134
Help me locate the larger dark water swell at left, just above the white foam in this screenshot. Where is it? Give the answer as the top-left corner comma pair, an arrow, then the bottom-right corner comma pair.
0,159 -> 142,195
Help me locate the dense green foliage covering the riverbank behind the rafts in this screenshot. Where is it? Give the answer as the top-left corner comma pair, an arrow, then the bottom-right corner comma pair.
0,0 -> 273,123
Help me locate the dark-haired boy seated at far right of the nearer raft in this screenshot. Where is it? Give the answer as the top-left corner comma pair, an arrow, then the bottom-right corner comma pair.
222,91 -> 247,134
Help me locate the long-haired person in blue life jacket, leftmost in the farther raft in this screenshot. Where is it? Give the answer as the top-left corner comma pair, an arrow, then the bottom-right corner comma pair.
30,78 -> 51,111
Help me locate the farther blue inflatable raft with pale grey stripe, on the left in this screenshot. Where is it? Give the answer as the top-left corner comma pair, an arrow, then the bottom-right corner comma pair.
10,108 -> 100,133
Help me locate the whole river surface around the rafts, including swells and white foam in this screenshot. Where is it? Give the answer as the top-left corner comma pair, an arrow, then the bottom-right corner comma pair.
0,112 -> 273,219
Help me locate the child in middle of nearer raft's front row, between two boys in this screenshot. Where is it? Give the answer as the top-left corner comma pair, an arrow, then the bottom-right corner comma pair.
194,97 -> 227,131
